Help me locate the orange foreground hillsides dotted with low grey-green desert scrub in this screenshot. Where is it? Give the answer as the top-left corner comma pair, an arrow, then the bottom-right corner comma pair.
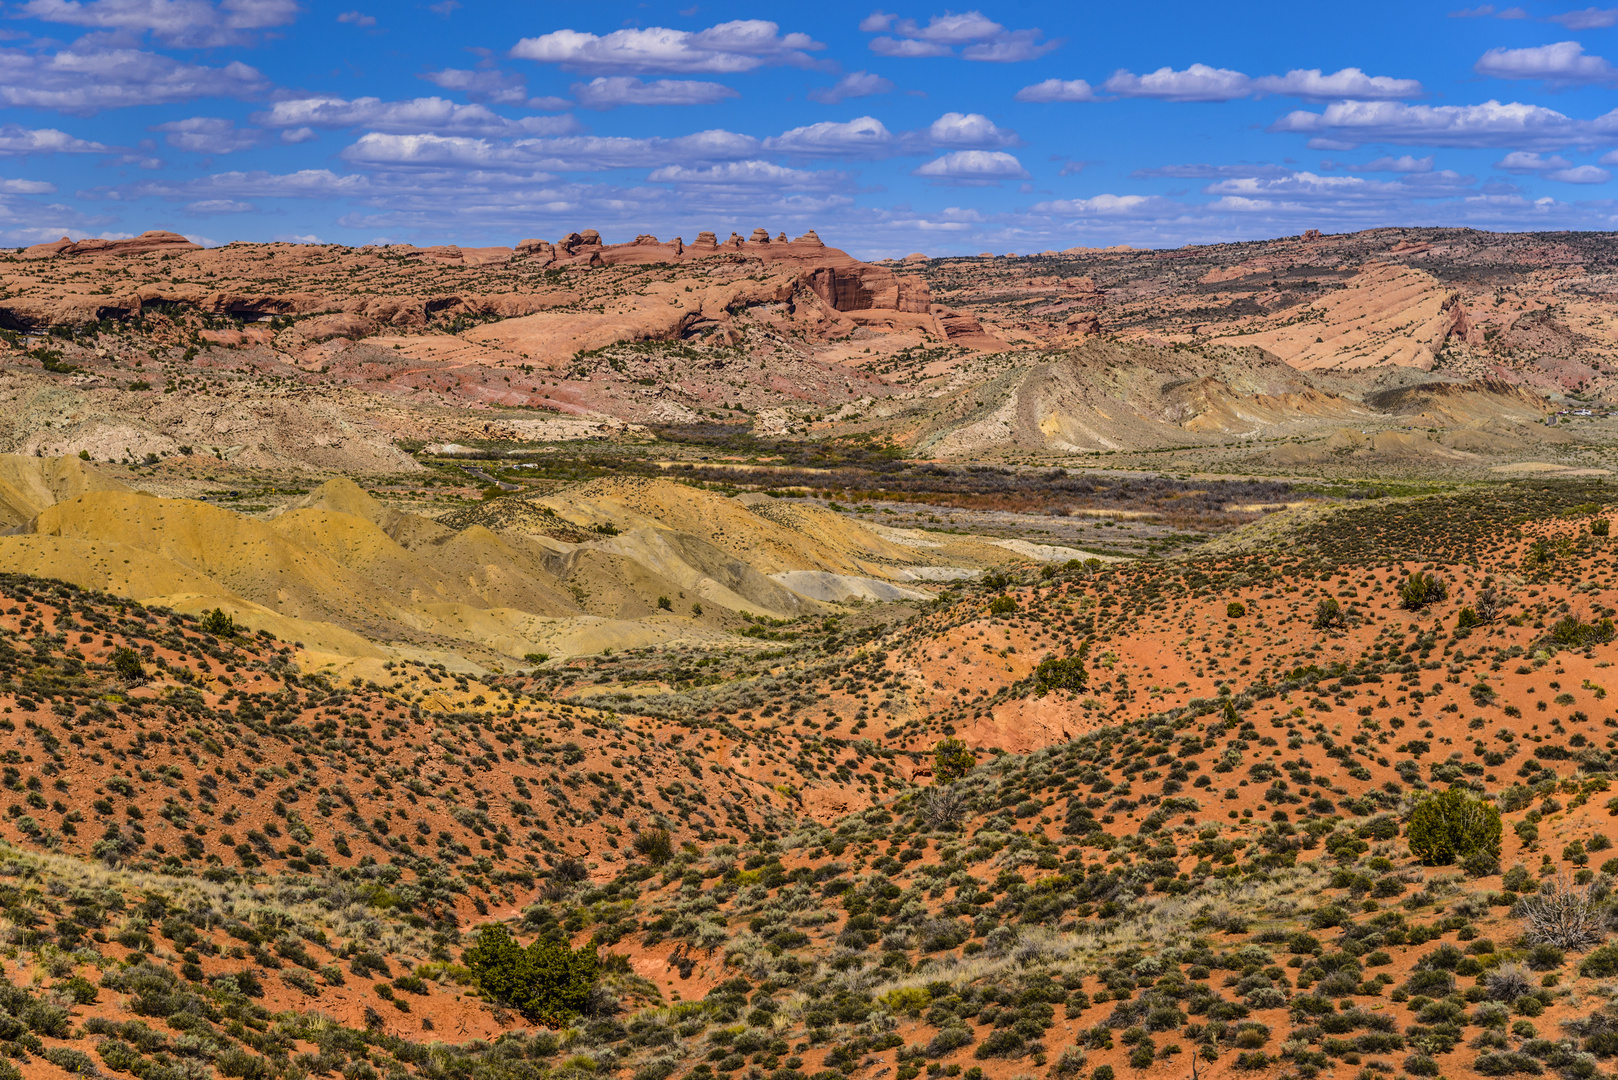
12,466 -> 1618,1080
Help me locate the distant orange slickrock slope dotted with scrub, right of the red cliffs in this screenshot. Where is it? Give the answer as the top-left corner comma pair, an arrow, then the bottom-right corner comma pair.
903,228 -> 1618,392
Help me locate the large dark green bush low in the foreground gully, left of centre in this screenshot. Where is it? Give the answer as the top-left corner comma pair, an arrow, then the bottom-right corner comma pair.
461,923 -> 600,1028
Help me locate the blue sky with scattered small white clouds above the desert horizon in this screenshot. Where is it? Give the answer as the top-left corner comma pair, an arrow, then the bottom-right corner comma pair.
0,0 -> 1618,256
